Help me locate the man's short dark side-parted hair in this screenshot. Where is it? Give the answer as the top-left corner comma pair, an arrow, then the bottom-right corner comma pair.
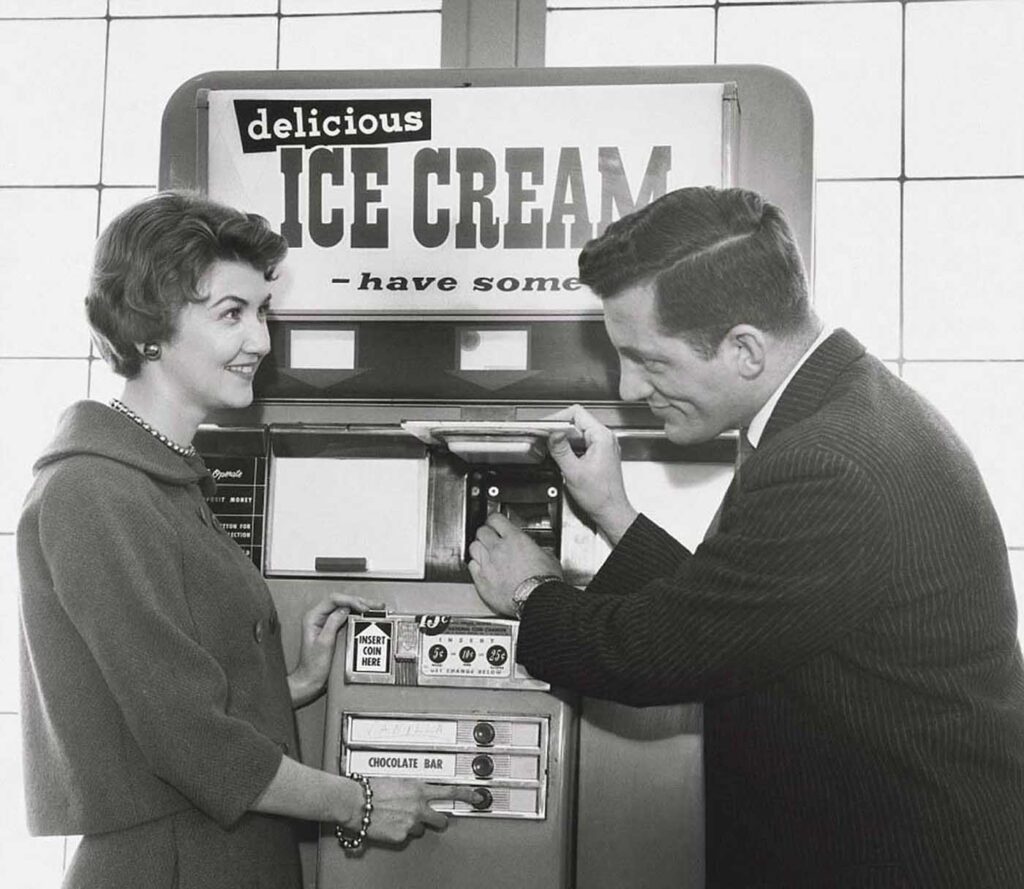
580,187 -> 811,357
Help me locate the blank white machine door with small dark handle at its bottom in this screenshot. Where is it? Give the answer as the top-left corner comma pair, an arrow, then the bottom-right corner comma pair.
267,457 -> 427,578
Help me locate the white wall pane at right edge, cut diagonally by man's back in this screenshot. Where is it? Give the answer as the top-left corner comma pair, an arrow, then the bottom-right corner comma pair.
903,362 -> 1024,547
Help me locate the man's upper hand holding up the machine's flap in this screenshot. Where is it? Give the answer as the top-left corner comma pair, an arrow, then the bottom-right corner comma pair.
548,405 -> 638,546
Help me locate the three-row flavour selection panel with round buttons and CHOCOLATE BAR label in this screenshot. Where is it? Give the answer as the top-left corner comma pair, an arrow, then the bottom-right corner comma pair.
340,713 -> 549,819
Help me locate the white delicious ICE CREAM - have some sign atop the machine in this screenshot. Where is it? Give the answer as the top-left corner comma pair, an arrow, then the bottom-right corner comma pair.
207,83 -> 735,312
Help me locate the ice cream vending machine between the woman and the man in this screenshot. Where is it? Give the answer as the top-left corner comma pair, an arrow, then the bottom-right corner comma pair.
161,67 -> 813,889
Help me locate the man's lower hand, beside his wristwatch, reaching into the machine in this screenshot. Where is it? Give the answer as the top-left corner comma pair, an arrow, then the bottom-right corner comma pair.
469,512 -> 562,615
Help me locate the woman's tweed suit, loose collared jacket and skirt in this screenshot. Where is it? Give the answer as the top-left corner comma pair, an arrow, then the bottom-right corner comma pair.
17,401 -> 299,889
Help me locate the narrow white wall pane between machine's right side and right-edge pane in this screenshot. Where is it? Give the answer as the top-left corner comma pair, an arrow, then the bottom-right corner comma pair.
814,182 -> 900,358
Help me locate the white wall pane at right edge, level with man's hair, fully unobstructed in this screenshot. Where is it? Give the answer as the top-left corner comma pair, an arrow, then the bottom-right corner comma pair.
903,179 -> 1024,358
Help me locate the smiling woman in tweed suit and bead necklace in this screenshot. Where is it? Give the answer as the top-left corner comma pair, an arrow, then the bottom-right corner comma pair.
17,193 -> 472,889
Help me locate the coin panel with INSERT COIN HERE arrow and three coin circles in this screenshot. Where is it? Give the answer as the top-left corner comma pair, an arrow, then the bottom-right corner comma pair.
345,611 -> 550,690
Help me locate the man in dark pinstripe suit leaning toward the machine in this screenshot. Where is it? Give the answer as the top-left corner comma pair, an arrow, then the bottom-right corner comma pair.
469,188 -> 1024,889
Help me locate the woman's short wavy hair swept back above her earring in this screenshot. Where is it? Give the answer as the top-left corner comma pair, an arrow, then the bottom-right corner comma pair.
85,192 -> 288,379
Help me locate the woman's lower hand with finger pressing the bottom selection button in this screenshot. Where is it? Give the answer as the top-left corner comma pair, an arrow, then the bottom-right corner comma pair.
344,777 -> 476,844
